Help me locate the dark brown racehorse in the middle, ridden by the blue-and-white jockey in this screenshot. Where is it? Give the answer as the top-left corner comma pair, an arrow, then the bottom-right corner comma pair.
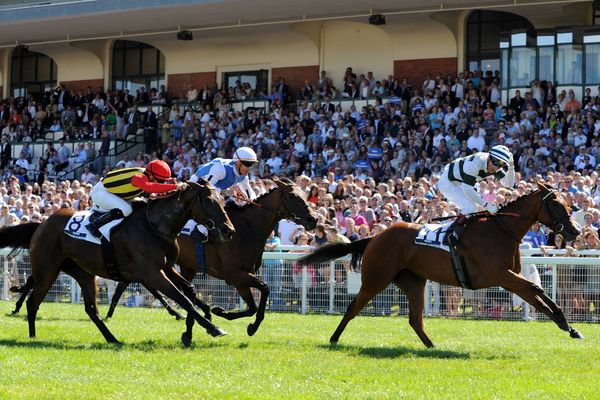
107,179 -> 317,345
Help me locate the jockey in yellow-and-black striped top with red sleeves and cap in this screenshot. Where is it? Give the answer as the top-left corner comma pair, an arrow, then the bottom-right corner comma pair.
86,160 -> 177,237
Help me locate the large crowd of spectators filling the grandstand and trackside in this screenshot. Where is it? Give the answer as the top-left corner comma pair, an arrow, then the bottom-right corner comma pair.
0,68 -> 600,320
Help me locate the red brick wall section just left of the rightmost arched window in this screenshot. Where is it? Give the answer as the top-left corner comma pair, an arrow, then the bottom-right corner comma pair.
394,57 -> 458,94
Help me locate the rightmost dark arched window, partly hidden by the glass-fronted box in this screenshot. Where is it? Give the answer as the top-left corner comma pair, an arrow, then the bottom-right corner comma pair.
466,10 -> 534,71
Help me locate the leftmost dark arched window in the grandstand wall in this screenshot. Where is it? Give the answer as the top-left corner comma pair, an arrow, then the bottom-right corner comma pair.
10,47 -> 57,99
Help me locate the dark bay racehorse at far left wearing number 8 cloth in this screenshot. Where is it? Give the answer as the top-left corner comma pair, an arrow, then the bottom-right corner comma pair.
0,180 -> 234,343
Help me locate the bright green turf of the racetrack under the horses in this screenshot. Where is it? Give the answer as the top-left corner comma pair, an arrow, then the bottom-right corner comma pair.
0,302 -> 600,400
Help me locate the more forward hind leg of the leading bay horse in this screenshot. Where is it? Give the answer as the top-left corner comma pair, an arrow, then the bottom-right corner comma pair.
394,270 -> 433,347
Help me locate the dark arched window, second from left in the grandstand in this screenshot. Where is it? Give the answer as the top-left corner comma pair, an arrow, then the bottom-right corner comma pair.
112,40 -> 165,94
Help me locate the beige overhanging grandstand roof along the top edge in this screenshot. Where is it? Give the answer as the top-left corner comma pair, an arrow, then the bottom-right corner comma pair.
0,0 -> 591,47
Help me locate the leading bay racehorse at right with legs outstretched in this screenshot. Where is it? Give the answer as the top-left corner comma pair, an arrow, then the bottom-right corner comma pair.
299,182 -> 583,347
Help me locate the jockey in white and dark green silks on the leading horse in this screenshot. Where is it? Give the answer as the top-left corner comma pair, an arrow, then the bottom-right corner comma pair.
438,145 -> 515,215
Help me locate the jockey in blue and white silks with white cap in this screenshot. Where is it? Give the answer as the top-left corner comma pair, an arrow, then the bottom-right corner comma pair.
190,147 -> 258,242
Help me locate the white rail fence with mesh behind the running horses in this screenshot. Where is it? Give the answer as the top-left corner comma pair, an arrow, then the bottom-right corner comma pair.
0,246 -> 600,322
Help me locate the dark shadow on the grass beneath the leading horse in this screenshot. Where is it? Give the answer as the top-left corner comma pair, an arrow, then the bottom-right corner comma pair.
317,344 -> 471,359
